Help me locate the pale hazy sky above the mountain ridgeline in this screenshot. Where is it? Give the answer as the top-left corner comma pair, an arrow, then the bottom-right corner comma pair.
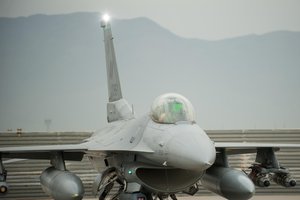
0,0 -> 300,39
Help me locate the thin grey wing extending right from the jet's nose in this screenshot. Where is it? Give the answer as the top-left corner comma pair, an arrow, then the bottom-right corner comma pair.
215,142 -> 300,155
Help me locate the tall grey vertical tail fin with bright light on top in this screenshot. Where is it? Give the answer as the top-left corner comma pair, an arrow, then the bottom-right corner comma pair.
101,15 -> 133,122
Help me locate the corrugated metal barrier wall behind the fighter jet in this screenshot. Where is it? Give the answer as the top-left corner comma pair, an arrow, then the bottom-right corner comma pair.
0,130 -> 300,200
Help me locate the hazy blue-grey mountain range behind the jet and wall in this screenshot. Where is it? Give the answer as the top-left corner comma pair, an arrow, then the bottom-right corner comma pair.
0,13 -> 300,131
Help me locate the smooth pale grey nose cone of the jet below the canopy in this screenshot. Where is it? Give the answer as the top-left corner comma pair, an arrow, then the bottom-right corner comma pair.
166,125 -> 216,171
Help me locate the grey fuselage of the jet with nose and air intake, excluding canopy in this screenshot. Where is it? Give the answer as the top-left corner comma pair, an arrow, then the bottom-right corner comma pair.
86,112 -> 216,192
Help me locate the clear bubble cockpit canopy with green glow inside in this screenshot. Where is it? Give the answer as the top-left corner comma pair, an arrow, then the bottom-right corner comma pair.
150,93 -> 195,124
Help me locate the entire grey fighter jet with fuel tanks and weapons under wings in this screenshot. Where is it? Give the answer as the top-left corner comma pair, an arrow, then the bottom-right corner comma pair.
0,15 -> 300,200
